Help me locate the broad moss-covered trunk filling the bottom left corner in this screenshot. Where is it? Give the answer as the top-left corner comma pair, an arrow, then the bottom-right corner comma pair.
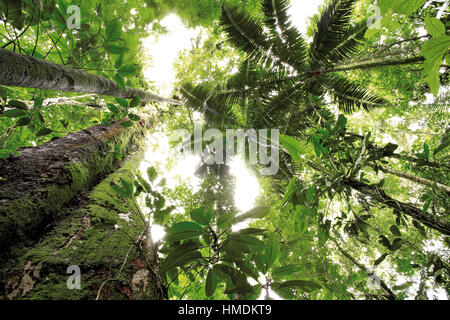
0,148 -> 167,300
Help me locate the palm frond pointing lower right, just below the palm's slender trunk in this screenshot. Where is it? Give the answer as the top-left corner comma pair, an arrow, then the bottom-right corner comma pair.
321,74 -> 387,113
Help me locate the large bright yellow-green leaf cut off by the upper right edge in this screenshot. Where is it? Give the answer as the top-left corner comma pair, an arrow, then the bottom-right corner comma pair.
422,36 -> 450,96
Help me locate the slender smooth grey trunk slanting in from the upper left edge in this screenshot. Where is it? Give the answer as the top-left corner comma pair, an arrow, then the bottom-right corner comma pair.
0,48 -> 181,105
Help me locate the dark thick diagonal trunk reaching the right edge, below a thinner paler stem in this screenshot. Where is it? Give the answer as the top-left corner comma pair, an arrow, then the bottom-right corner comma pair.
344,179 -> 450,236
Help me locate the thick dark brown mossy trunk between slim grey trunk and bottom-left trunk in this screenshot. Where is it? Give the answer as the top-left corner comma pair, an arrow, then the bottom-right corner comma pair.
0,116 -> 155,260
